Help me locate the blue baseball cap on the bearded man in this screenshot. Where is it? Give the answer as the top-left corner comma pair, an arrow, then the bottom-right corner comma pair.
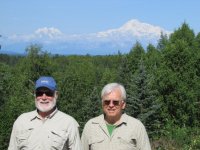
35,76 -> 56,91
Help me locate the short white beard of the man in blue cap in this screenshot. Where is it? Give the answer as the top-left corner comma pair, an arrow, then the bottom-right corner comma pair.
35,97 -> 57,112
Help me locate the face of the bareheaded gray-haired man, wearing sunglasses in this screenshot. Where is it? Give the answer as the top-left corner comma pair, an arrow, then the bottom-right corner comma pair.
102,89 -> 126,120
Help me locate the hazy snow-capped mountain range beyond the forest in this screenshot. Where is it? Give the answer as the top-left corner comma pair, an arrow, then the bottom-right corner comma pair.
0,19 -> 171,55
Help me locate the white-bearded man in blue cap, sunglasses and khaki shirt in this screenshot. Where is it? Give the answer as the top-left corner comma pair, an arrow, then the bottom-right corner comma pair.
8,76 -> 81,150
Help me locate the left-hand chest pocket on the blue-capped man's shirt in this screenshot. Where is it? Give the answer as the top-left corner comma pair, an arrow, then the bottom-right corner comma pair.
16,128 -> 33,150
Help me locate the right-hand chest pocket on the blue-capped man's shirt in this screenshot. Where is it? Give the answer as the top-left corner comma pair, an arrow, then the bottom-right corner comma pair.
48,129 -> 68,150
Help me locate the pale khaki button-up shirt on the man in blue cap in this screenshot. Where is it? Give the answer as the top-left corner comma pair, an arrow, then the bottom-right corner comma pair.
8,110 -> 81,150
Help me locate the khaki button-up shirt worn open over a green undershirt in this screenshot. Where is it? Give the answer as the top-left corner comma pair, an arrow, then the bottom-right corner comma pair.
81,114 -> 151,150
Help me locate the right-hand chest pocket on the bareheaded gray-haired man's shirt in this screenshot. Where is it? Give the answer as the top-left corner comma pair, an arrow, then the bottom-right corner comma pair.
116,136 -> 138,150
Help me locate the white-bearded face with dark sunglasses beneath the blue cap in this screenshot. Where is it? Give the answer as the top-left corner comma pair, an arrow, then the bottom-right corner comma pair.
35,87 -> 57,112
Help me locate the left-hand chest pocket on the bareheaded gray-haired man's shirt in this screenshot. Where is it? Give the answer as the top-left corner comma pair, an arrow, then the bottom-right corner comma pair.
89,136 -> 104,150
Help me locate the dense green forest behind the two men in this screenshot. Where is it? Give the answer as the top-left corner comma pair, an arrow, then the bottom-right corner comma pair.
0,22 -> 200,150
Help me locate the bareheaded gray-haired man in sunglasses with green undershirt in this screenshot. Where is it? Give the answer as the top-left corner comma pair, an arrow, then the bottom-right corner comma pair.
81,83 -> 151,150
